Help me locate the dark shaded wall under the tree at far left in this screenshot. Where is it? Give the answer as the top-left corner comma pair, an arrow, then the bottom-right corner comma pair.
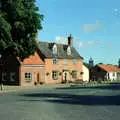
0,55 -> 20,85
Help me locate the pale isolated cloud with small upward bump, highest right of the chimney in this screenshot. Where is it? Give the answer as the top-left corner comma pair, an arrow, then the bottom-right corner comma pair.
82,20 -> 103,32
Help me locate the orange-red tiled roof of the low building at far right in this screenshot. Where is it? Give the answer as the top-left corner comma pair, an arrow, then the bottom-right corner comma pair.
97,64 -> 120,72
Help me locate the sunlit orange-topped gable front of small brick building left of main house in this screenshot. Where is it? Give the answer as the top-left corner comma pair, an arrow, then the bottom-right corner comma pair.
19,52 -> 45,86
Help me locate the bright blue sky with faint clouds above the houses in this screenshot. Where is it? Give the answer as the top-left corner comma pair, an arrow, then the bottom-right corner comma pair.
36,0 -> 120,64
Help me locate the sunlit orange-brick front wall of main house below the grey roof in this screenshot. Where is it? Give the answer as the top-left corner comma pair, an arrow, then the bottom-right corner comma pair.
45,59 -> 83,83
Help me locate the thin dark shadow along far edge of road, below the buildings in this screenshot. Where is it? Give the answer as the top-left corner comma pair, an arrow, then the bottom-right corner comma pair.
56,83 -> 120,90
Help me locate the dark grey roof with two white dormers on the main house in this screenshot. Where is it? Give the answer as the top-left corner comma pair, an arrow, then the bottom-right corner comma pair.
38,41 -> 83,59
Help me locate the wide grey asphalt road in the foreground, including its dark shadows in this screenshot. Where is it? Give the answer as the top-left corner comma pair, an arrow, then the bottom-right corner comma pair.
0,85 -> 120,120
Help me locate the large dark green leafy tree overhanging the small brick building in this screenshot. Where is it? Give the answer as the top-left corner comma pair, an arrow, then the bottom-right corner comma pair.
0,0 -> 44,60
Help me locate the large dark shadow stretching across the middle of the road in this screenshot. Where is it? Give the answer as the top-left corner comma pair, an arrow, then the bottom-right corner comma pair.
22,93 -> 120,105
